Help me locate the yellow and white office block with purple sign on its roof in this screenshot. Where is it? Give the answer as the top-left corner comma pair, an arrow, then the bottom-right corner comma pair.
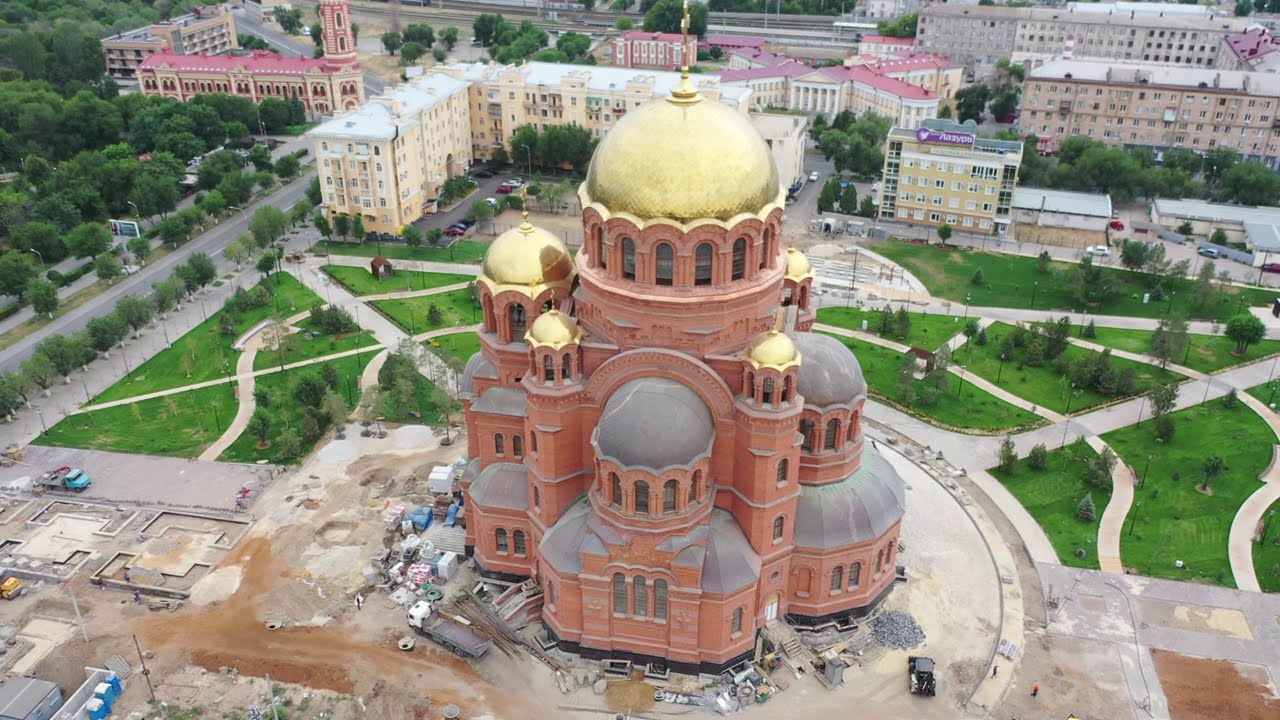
879,119 -> 1023,234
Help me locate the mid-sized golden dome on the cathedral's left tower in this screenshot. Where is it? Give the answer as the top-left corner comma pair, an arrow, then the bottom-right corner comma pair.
480,211 -> 575,295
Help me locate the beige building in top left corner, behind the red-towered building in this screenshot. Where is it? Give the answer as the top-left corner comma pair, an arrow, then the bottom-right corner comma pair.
102,5 -> 239,78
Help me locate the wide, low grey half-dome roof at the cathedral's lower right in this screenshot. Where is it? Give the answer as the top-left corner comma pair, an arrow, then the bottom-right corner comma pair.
795,446 -> 906,550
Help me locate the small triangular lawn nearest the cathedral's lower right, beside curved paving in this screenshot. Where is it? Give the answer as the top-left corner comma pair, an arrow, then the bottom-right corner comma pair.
991,442 -> 1111,570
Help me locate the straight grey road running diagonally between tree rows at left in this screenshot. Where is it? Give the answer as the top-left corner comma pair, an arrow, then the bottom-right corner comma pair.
0,170 -> 315,370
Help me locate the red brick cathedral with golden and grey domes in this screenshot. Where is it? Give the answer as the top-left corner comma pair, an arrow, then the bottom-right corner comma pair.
461,33 -> 905,671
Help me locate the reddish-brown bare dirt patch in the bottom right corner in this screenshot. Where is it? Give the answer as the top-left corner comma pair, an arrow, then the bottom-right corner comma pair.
1151,650 -> 1280,720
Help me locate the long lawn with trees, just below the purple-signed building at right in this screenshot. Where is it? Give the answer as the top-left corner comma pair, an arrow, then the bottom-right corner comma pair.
872,241 -> 1275,320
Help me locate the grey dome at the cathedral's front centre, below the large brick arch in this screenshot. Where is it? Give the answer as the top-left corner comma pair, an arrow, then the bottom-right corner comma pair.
593,378 -> 716,470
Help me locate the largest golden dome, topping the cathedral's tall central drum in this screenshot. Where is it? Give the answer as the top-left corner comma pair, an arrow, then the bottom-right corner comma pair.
586,79 -> 782,222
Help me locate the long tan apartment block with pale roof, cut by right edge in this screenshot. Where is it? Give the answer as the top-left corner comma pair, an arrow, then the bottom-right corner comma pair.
1021,60 -> 1280,168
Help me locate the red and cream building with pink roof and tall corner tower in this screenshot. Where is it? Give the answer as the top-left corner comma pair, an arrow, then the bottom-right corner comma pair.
137,0 -> 365,118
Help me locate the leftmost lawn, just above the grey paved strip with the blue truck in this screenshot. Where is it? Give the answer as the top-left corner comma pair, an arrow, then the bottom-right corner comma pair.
35,386 -> 236,457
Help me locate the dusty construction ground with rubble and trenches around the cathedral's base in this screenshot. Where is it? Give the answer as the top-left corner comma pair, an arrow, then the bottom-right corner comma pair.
0,415 -> 1276,720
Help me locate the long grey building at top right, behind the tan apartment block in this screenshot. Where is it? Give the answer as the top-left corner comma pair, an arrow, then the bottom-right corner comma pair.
915,4 -> 1249,72
